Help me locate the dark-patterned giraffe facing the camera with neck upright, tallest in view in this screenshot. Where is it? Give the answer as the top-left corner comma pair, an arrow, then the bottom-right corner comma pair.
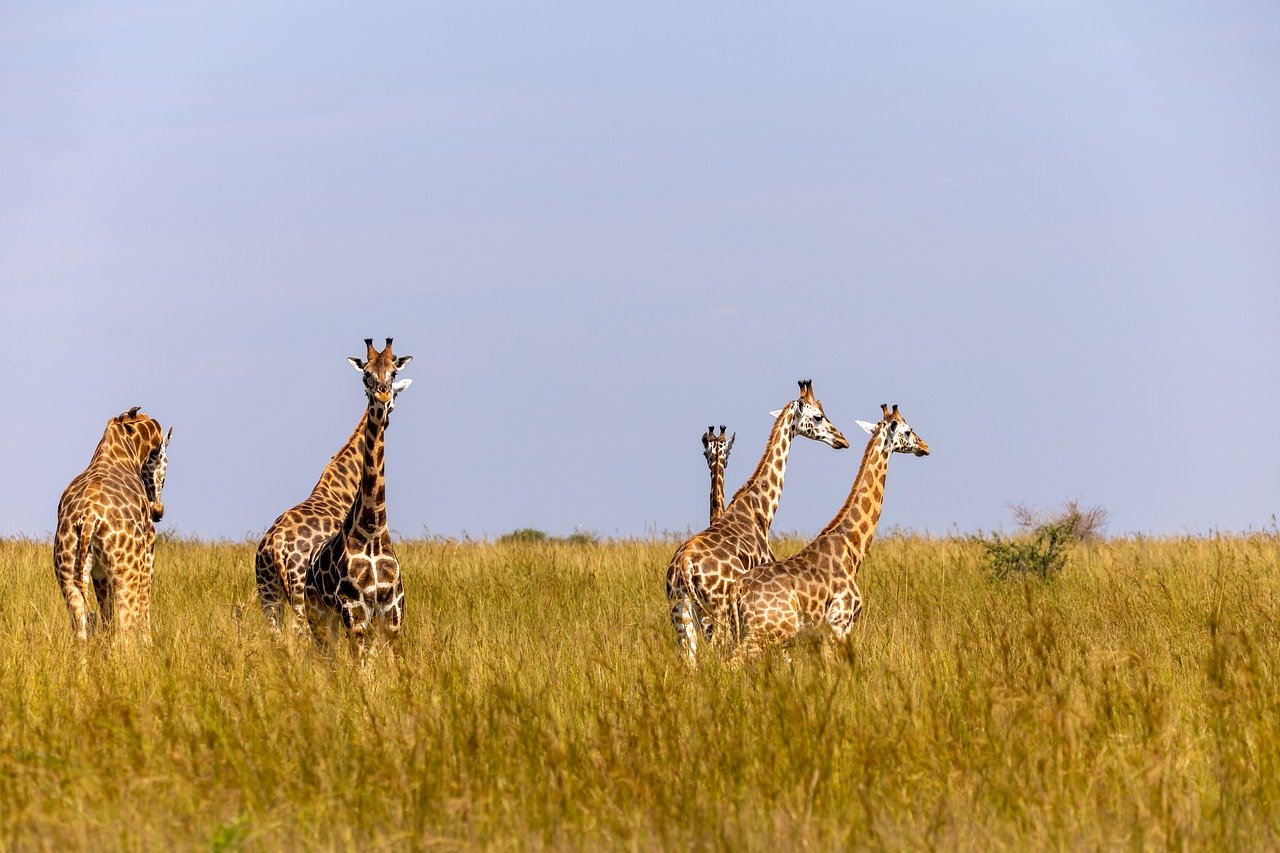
305,338 -> 413,652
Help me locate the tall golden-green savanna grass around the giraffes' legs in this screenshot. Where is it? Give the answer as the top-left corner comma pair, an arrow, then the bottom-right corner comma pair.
0,534 -> 1280,849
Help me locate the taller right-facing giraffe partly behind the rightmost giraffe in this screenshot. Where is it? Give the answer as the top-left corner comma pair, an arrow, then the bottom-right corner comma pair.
667,379 -> 849,663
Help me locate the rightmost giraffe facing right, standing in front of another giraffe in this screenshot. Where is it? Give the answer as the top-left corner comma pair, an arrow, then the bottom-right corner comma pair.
732,405 -> 929,661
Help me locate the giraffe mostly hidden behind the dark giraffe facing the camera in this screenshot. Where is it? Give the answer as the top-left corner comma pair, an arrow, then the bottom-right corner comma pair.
253,414 -> 369,633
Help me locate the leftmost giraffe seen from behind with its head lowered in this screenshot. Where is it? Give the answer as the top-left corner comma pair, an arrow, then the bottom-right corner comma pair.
54,406 -> 173,640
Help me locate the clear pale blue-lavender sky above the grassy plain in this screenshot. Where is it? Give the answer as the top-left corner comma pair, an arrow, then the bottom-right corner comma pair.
0,0 -> 1280,538
